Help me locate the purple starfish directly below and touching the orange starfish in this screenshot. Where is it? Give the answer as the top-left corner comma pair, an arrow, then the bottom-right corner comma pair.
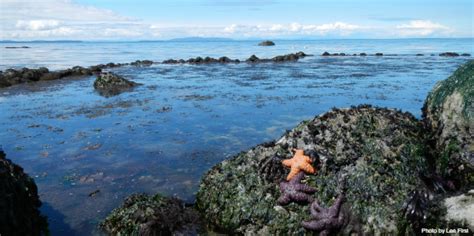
277,172 -> 316,206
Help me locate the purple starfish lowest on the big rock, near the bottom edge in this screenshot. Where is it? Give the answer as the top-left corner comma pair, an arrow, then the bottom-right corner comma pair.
301,194 -> 345,236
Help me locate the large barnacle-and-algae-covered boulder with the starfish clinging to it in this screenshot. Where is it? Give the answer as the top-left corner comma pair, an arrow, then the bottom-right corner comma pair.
196,106 -> 427,235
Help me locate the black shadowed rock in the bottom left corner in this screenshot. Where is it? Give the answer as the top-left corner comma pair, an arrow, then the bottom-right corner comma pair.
0,148 -> 48,235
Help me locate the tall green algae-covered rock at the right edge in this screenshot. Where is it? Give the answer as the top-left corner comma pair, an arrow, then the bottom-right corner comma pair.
423,60 -> 474,188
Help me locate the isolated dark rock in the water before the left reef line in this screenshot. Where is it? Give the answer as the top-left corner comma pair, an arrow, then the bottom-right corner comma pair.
94,72 -> 140,97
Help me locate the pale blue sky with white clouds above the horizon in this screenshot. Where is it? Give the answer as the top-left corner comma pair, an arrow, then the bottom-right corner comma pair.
0,0 -> 474,40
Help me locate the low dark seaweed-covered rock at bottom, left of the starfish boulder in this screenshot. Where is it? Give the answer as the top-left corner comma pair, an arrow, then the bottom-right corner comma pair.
100,194 -> 200,235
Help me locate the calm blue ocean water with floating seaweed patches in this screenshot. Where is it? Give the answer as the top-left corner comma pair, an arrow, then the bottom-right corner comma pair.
0,39 -> 474,235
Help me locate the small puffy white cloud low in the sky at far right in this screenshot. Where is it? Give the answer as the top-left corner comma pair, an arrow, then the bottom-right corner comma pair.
396,20 -> 452,36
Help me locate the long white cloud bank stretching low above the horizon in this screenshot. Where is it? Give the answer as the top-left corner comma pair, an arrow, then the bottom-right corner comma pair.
0,0 -> 460,40
